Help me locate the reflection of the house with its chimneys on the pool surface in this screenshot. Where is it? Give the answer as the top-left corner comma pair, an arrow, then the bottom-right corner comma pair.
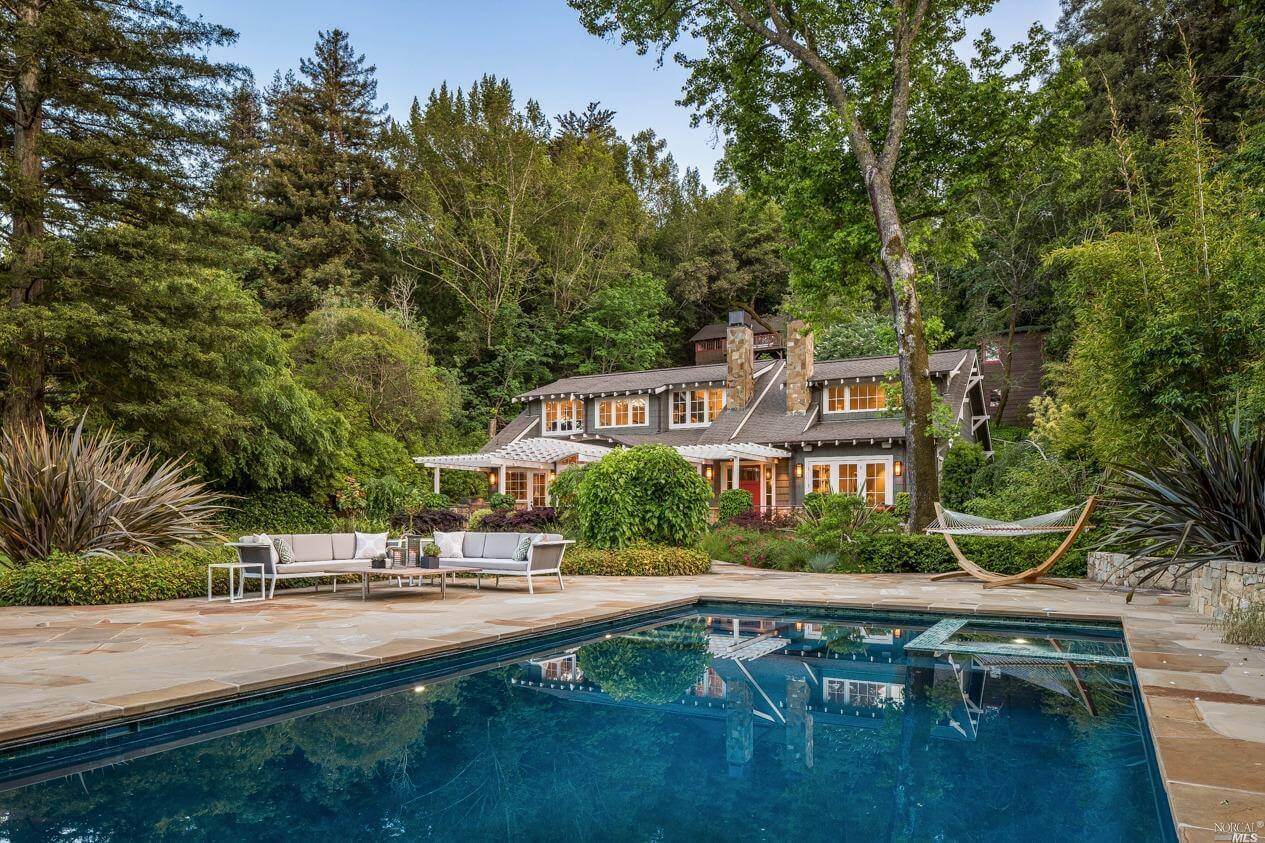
516,618 -> 984,739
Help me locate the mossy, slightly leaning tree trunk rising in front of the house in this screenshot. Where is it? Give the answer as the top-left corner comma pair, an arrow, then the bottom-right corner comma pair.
864,168 -> 940,533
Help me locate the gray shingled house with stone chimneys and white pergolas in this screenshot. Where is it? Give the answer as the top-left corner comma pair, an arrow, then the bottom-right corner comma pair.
416,319 -> 992,510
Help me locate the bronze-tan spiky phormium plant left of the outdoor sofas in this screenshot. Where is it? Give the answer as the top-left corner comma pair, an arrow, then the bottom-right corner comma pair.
0,419 -> 221,565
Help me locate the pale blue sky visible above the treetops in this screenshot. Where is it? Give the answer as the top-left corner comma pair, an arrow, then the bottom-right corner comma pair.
183,0 -> 1059,181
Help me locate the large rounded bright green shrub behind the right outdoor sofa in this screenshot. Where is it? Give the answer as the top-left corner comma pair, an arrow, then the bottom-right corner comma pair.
576,444 -> 711,548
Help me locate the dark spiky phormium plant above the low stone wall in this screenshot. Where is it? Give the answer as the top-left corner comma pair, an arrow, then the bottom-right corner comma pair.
1099,415 -> 1265,585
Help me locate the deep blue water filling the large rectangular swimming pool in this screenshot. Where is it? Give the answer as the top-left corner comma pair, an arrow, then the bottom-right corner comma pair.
0,605 -> 1175,843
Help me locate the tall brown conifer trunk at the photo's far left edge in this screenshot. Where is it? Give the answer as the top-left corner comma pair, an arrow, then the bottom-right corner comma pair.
4,0 -> 46,423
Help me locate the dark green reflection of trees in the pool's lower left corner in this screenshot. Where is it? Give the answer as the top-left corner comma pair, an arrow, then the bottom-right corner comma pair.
0,694 -> 440,842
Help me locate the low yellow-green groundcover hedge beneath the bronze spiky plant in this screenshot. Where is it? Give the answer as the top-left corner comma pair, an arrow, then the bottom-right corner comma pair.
0,556 -> 216,606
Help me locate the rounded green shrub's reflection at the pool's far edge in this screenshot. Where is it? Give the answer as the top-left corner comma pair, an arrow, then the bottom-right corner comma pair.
577,618 -> 711,704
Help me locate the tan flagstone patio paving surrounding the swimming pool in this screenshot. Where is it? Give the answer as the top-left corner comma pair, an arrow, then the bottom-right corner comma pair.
0,566 -> 1265,840
